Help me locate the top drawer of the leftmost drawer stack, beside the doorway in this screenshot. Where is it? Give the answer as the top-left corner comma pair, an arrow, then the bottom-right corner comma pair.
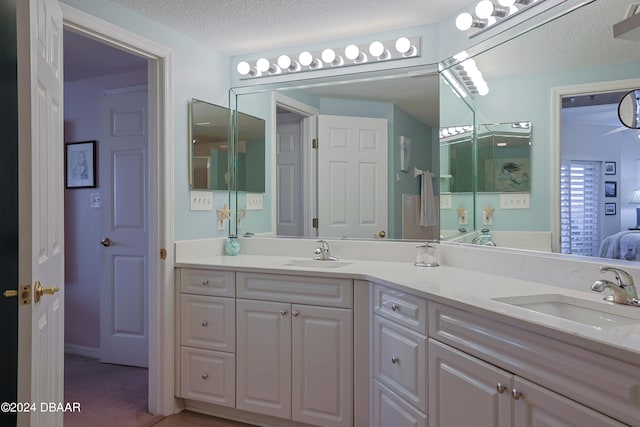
180,268 -> 236,297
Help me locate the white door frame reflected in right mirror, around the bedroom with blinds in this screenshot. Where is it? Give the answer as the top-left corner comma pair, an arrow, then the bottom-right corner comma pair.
549,78 -> 640,253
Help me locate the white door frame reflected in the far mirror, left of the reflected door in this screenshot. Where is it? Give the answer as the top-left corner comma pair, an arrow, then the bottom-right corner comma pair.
271,91 -> 320,237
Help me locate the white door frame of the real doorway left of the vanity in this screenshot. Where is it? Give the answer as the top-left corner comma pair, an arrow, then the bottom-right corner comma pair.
61,3 -> 176,415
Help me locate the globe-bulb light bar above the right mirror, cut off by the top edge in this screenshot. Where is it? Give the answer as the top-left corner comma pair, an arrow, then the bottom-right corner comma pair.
456,0 -> 544,37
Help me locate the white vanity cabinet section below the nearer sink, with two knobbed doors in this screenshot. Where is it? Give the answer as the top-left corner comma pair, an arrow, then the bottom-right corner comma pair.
429,303 -> 640,427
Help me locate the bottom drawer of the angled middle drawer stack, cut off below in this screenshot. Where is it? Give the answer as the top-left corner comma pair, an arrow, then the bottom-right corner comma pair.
371,381 -> 427,427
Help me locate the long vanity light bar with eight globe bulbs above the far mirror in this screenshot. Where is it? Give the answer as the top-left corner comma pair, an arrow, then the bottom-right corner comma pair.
236,37 -> 420,79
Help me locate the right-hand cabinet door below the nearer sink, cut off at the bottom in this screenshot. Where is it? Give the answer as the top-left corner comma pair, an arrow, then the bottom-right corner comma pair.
514,377 -> 626,427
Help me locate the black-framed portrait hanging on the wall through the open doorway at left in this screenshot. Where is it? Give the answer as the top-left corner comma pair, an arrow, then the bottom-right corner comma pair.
64,141 -> 96,188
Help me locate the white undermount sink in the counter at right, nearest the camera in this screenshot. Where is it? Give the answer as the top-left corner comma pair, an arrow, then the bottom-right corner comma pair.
493,294 -> 640,329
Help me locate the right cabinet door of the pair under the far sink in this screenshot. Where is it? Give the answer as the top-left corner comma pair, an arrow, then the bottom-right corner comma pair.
291,305 -> 353,427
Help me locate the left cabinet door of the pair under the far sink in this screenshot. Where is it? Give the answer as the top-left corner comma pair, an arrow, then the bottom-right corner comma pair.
236,299 -> 291,418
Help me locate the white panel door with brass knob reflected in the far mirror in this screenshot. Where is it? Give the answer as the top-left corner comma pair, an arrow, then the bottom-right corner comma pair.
318,115 -> 388,237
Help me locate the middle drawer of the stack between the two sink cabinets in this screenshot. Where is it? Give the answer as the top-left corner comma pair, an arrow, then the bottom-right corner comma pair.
373,316 -> 428,412
